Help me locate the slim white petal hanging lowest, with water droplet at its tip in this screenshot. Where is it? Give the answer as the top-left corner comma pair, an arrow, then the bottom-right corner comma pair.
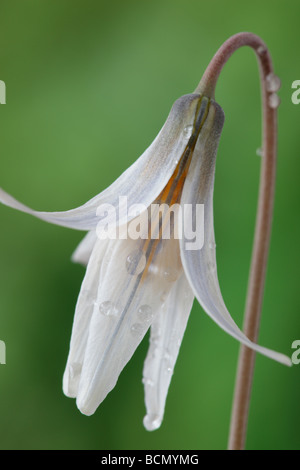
143,273 -> 194,431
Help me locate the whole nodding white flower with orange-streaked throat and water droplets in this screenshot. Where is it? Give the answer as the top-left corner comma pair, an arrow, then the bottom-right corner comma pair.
0,93 -> 290,430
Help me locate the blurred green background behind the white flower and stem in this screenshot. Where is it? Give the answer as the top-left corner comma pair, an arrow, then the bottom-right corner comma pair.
0,0 -> 300,450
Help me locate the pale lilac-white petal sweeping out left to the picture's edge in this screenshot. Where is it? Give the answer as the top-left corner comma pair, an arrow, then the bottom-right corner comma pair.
0,94 -> 200,230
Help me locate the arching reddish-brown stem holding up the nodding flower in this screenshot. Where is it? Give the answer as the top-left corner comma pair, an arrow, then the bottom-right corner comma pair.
196,33 -> 280,450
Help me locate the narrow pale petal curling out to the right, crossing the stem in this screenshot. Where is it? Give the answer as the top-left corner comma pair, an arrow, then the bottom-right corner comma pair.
180,99 -> 291,365
